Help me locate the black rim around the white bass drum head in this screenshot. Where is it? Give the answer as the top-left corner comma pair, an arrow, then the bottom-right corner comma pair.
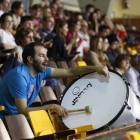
59,69 -> 129,134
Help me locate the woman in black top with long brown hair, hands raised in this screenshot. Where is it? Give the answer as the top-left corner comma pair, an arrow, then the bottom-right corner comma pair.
48,21 -> 73,61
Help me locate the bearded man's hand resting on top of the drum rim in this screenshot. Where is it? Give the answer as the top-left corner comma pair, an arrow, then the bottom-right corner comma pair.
95,65 -> 109,77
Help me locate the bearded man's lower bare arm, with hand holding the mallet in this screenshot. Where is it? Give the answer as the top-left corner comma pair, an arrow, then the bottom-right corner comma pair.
15,98 -> 68,117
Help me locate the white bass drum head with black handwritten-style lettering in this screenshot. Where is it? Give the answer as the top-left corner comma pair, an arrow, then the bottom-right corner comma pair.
60,71 -> 129,132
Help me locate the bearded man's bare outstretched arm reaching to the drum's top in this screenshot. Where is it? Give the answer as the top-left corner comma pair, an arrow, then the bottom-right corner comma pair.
49,65 -> 109,78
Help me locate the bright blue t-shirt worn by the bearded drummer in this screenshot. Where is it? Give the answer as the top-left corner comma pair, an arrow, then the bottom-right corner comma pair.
0,64 -> 51,118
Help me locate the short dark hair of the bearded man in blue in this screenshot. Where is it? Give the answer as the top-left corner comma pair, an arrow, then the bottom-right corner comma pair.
22,42 -> 44,64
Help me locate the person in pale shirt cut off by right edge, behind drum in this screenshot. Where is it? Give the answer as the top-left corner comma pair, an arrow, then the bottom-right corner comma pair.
123,53 -> 140,98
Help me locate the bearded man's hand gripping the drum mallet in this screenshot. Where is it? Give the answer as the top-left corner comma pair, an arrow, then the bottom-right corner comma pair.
51,104 -> 68,117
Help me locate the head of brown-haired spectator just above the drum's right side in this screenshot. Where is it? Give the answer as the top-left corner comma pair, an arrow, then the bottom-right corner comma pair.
114,54 -> 131,75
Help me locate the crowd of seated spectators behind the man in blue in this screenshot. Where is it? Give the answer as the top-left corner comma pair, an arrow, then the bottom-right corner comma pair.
0,0 -> 140,108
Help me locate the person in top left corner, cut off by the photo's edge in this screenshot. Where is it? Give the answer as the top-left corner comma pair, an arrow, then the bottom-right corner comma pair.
0,0 -> 11,16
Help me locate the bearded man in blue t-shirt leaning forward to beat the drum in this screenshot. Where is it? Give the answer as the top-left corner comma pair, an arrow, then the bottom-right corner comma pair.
0,42 -> 108,118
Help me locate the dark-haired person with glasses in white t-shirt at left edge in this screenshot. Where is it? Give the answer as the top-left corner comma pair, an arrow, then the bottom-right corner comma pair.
0,13 -> 17,50
